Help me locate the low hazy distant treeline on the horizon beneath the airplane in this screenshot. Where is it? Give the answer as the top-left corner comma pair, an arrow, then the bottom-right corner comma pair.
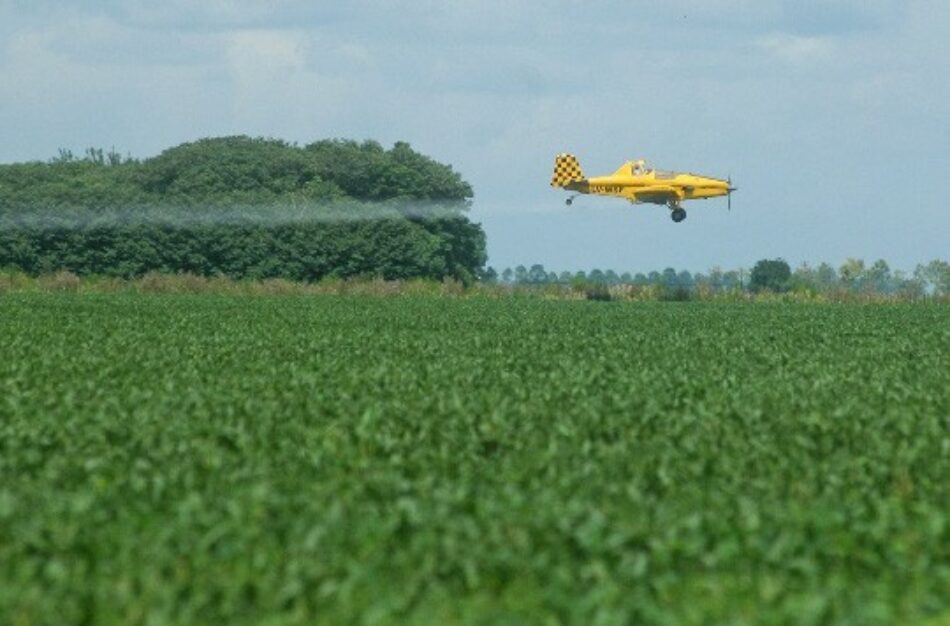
485,259 -> 950,297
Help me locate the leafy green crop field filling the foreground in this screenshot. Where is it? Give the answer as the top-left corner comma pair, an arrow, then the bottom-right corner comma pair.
0,293 -> 950,626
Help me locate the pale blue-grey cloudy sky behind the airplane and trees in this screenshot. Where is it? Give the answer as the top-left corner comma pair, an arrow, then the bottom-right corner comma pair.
0,0 -> 950,271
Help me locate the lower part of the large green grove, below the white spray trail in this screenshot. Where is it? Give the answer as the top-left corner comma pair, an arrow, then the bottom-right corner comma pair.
0,218 -> 483,281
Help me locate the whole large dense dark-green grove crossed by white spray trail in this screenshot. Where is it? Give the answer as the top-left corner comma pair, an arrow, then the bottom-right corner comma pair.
0,137 -> 486,282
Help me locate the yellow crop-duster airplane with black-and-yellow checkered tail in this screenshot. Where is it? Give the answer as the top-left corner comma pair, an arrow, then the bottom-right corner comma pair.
551,154 -> 737,222
